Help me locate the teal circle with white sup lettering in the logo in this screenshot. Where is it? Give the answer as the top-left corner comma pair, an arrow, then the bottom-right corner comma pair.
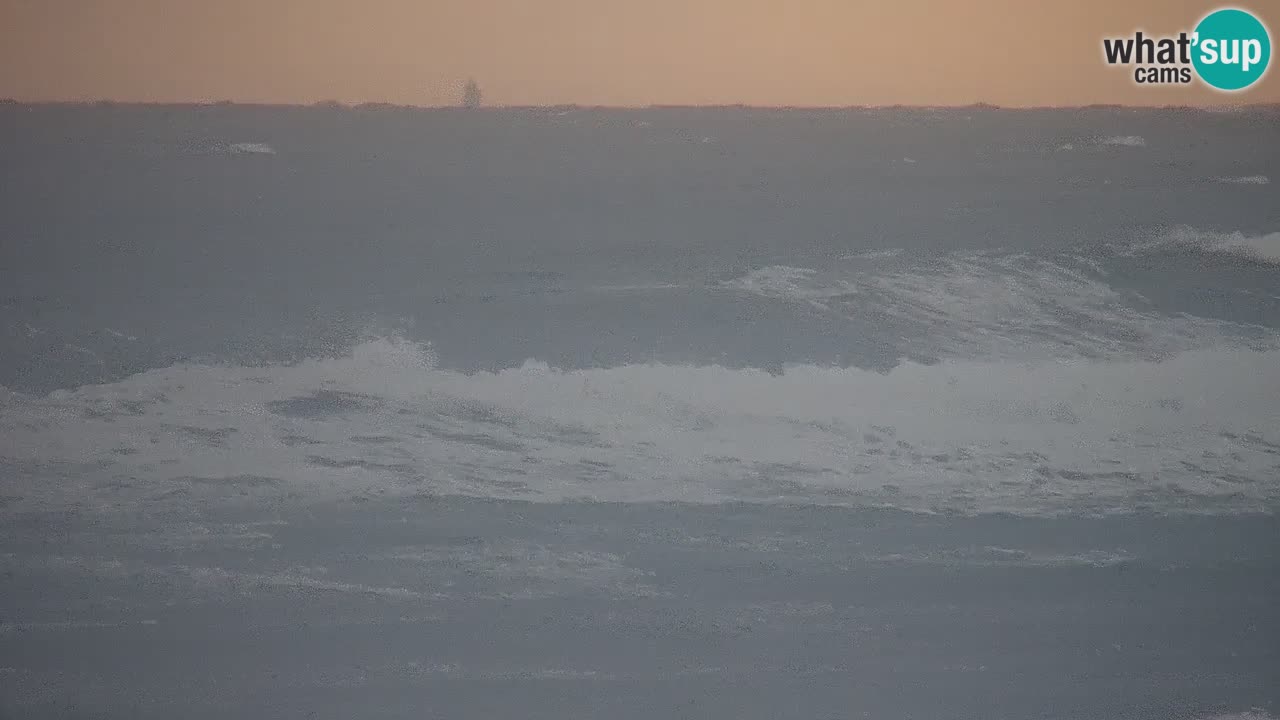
1192,8 -> 1271,91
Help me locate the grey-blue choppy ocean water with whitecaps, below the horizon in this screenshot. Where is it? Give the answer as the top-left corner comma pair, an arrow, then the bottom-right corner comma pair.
0,105 -> 1280,720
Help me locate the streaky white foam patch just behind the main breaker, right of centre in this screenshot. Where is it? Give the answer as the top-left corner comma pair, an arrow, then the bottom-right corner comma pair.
722,249 -> 1274,360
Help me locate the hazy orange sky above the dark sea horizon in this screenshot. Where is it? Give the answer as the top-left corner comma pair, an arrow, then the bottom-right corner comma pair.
0,0 -> 1280,105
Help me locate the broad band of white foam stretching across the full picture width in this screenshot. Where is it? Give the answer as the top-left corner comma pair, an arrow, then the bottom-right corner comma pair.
0,330 -> 1280,514
